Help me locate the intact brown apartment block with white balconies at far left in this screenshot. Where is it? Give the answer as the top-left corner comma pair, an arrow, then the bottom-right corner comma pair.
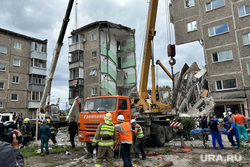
0,28 -> 47,118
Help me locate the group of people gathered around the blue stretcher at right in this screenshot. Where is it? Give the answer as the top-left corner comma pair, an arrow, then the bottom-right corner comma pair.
201,111 -> 248,149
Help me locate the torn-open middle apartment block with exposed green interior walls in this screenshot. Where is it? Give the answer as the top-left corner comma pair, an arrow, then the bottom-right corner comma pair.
69,21 -> 137,105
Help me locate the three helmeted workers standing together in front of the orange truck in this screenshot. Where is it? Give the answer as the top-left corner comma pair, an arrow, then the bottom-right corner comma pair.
92,113 -> 146,167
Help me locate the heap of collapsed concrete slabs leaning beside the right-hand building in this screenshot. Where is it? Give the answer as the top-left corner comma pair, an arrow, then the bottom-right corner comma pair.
173,63 -> 215,117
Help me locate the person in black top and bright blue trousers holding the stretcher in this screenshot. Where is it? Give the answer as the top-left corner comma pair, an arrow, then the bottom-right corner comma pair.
208,116 -> 224,150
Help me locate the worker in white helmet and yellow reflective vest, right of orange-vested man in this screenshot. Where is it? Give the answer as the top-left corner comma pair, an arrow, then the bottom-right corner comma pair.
131,119 -> 146,160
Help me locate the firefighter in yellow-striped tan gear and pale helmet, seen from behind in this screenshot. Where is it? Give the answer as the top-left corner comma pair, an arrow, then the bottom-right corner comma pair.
92,113 -> 116,167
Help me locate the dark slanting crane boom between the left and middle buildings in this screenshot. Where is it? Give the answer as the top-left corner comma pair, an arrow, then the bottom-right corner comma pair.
39,0 -> 74,112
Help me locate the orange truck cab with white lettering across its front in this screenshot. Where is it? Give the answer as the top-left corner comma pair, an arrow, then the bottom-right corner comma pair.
78,96 -> 131,151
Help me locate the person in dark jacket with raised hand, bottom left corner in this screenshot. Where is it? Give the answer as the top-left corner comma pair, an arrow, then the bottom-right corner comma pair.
0,130 -> 24,167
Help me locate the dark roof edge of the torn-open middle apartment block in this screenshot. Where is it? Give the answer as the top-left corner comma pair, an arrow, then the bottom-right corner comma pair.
71,21 -> 135,35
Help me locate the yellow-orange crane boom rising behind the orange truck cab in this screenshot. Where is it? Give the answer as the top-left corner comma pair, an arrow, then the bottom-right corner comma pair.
139,0 -> 158,99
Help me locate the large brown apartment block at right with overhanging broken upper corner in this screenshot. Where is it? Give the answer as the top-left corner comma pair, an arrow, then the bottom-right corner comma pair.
170,0 -> 250,117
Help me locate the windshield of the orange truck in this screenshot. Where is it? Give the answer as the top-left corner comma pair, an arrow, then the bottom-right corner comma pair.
83,97 -> 117,112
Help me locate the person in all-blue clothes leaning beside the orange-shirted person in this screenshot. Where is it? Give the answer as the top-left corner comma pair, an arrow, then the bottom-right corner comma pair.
226,118 -> 240,149
